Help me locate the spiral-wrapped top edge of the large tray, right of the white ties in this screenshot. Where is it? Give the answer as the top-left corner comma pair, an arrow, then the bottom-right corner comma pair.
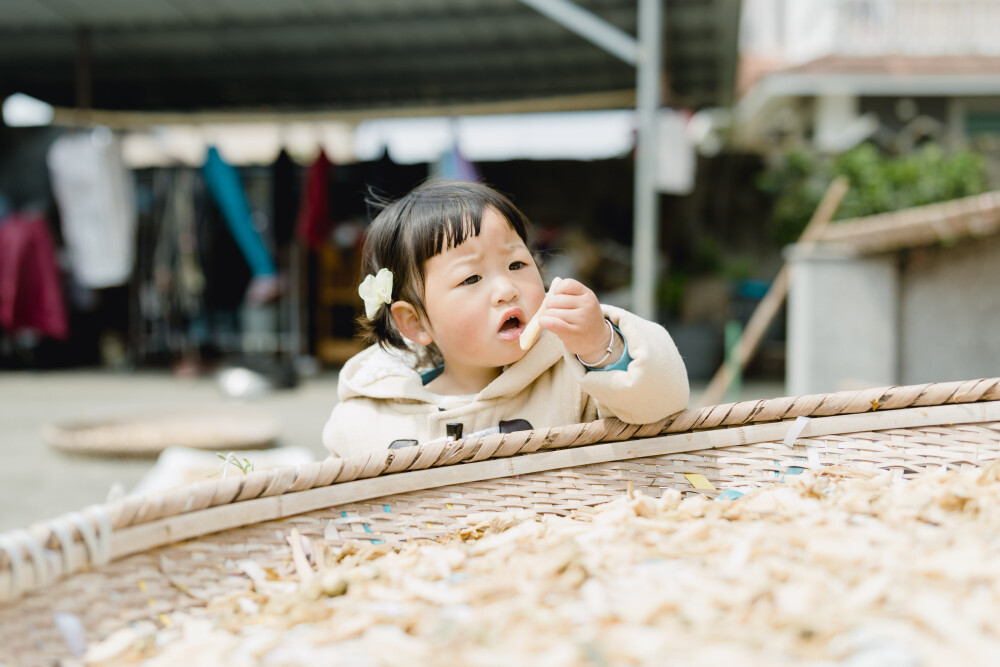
15,378 -> 1000,537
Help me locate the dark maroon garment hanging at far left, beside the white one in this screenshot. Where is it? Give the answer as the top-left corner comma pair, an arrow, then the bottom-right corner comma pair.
0,213 -> 69,340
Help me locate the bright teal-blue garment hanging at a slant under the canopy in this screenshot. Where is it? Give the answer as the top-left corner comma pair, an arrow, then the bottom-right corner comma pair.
201,146 -> 277,276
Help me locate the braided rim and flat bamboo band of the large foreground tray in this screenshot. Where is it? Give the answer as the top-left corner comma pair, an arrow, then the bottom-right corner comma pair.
0,378 -> 1000,601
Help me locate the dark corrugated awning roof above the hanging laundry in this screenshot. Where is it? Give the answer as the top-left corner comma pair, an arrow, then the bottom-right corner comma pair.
0,0 -> 739,117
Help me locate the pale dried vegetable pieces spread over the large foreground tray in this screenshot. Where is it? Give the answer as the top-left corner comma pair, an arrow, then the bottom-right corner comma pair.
87,464 -> 1000,667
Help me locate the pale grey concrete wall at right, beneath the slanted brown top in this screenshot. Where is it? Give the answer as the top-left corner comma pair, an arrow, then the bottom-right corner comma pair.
786,236 -> 1000,395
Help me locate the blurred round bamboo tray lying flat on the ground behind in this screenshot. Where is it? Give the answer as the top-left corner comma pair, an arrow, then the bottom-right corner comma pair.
44,408 -> 278,458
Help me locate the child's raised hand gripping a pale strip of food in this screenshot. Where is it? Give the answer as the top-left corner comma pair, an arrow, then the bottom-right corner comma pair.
538,278 -> 609,362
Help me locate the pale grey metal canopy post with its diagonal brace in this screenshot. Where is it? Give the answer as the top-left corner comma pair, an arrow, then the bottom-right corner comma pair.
521,0 -> 663,321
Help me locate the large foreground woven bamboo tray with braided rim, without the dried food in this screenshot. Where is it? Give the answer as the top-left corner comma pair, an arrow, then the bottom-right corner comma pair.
0,379 -> 1000,665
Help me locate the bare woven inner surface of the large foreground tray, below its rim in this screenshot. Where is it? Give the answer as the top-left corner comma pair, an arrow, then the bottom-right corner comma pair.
0,414 -> 1000,665
